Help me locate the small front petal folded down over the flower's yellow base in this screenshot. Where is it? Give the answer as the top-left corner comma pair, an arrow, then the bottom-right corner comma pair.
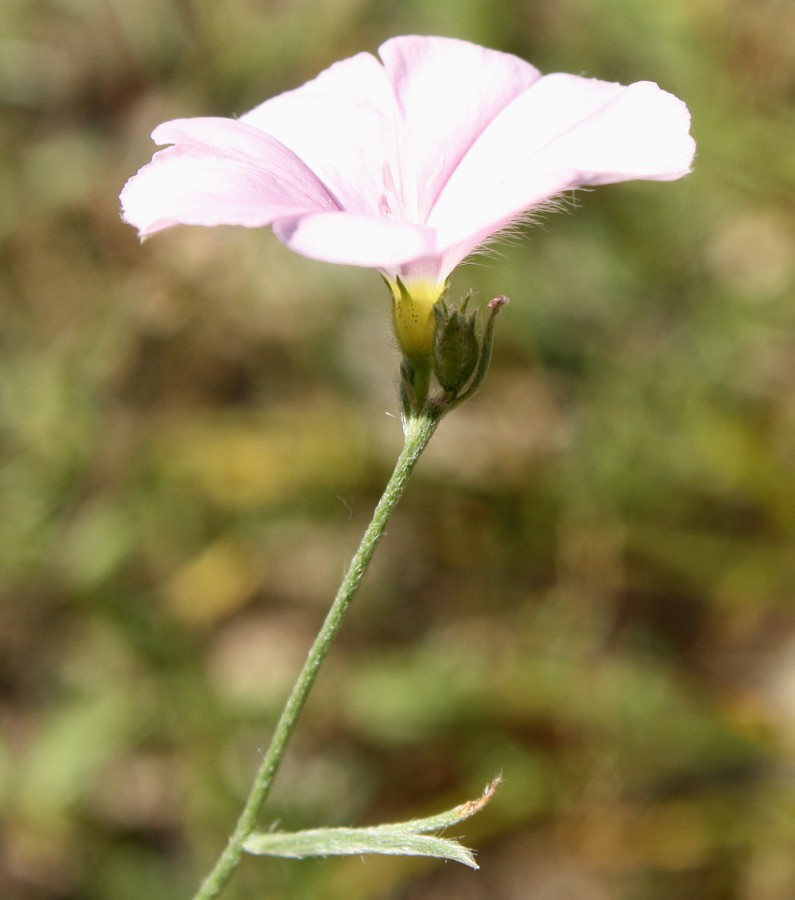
273,213 -> 435,272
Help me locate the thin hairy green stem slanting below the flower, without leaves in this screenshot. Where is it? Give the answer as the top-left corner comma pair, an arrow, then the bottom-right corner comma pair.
193,405 -> 442,900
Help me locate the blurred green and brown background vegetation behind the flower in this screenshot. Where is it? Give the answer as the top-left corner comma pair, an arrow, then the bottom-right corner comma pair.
0,0 -> 795,900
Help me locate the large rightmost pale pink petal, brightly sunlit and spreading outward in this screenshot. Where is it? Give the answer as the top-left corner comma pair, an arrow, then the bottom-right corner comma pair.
428,74 -> 695,265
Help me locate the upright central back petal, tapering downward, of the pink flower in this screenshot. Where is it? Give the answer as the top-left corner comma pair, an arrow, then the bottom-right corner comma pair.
378,35 -> 541,222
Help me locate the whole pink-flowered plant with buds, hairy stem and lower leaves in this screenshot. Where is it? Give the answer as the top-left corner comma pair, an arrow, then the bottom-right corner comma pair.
121,36 -> 695,900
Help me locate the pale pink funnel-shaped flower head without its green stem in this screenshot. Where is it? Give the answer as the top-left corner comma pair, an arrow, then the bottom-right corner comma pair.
121,36 -> 695,356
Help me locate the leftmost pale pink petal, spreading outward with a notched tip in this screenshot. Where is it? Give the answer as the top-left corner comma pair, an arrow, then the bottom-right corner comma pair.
121,118 -> 338,237
